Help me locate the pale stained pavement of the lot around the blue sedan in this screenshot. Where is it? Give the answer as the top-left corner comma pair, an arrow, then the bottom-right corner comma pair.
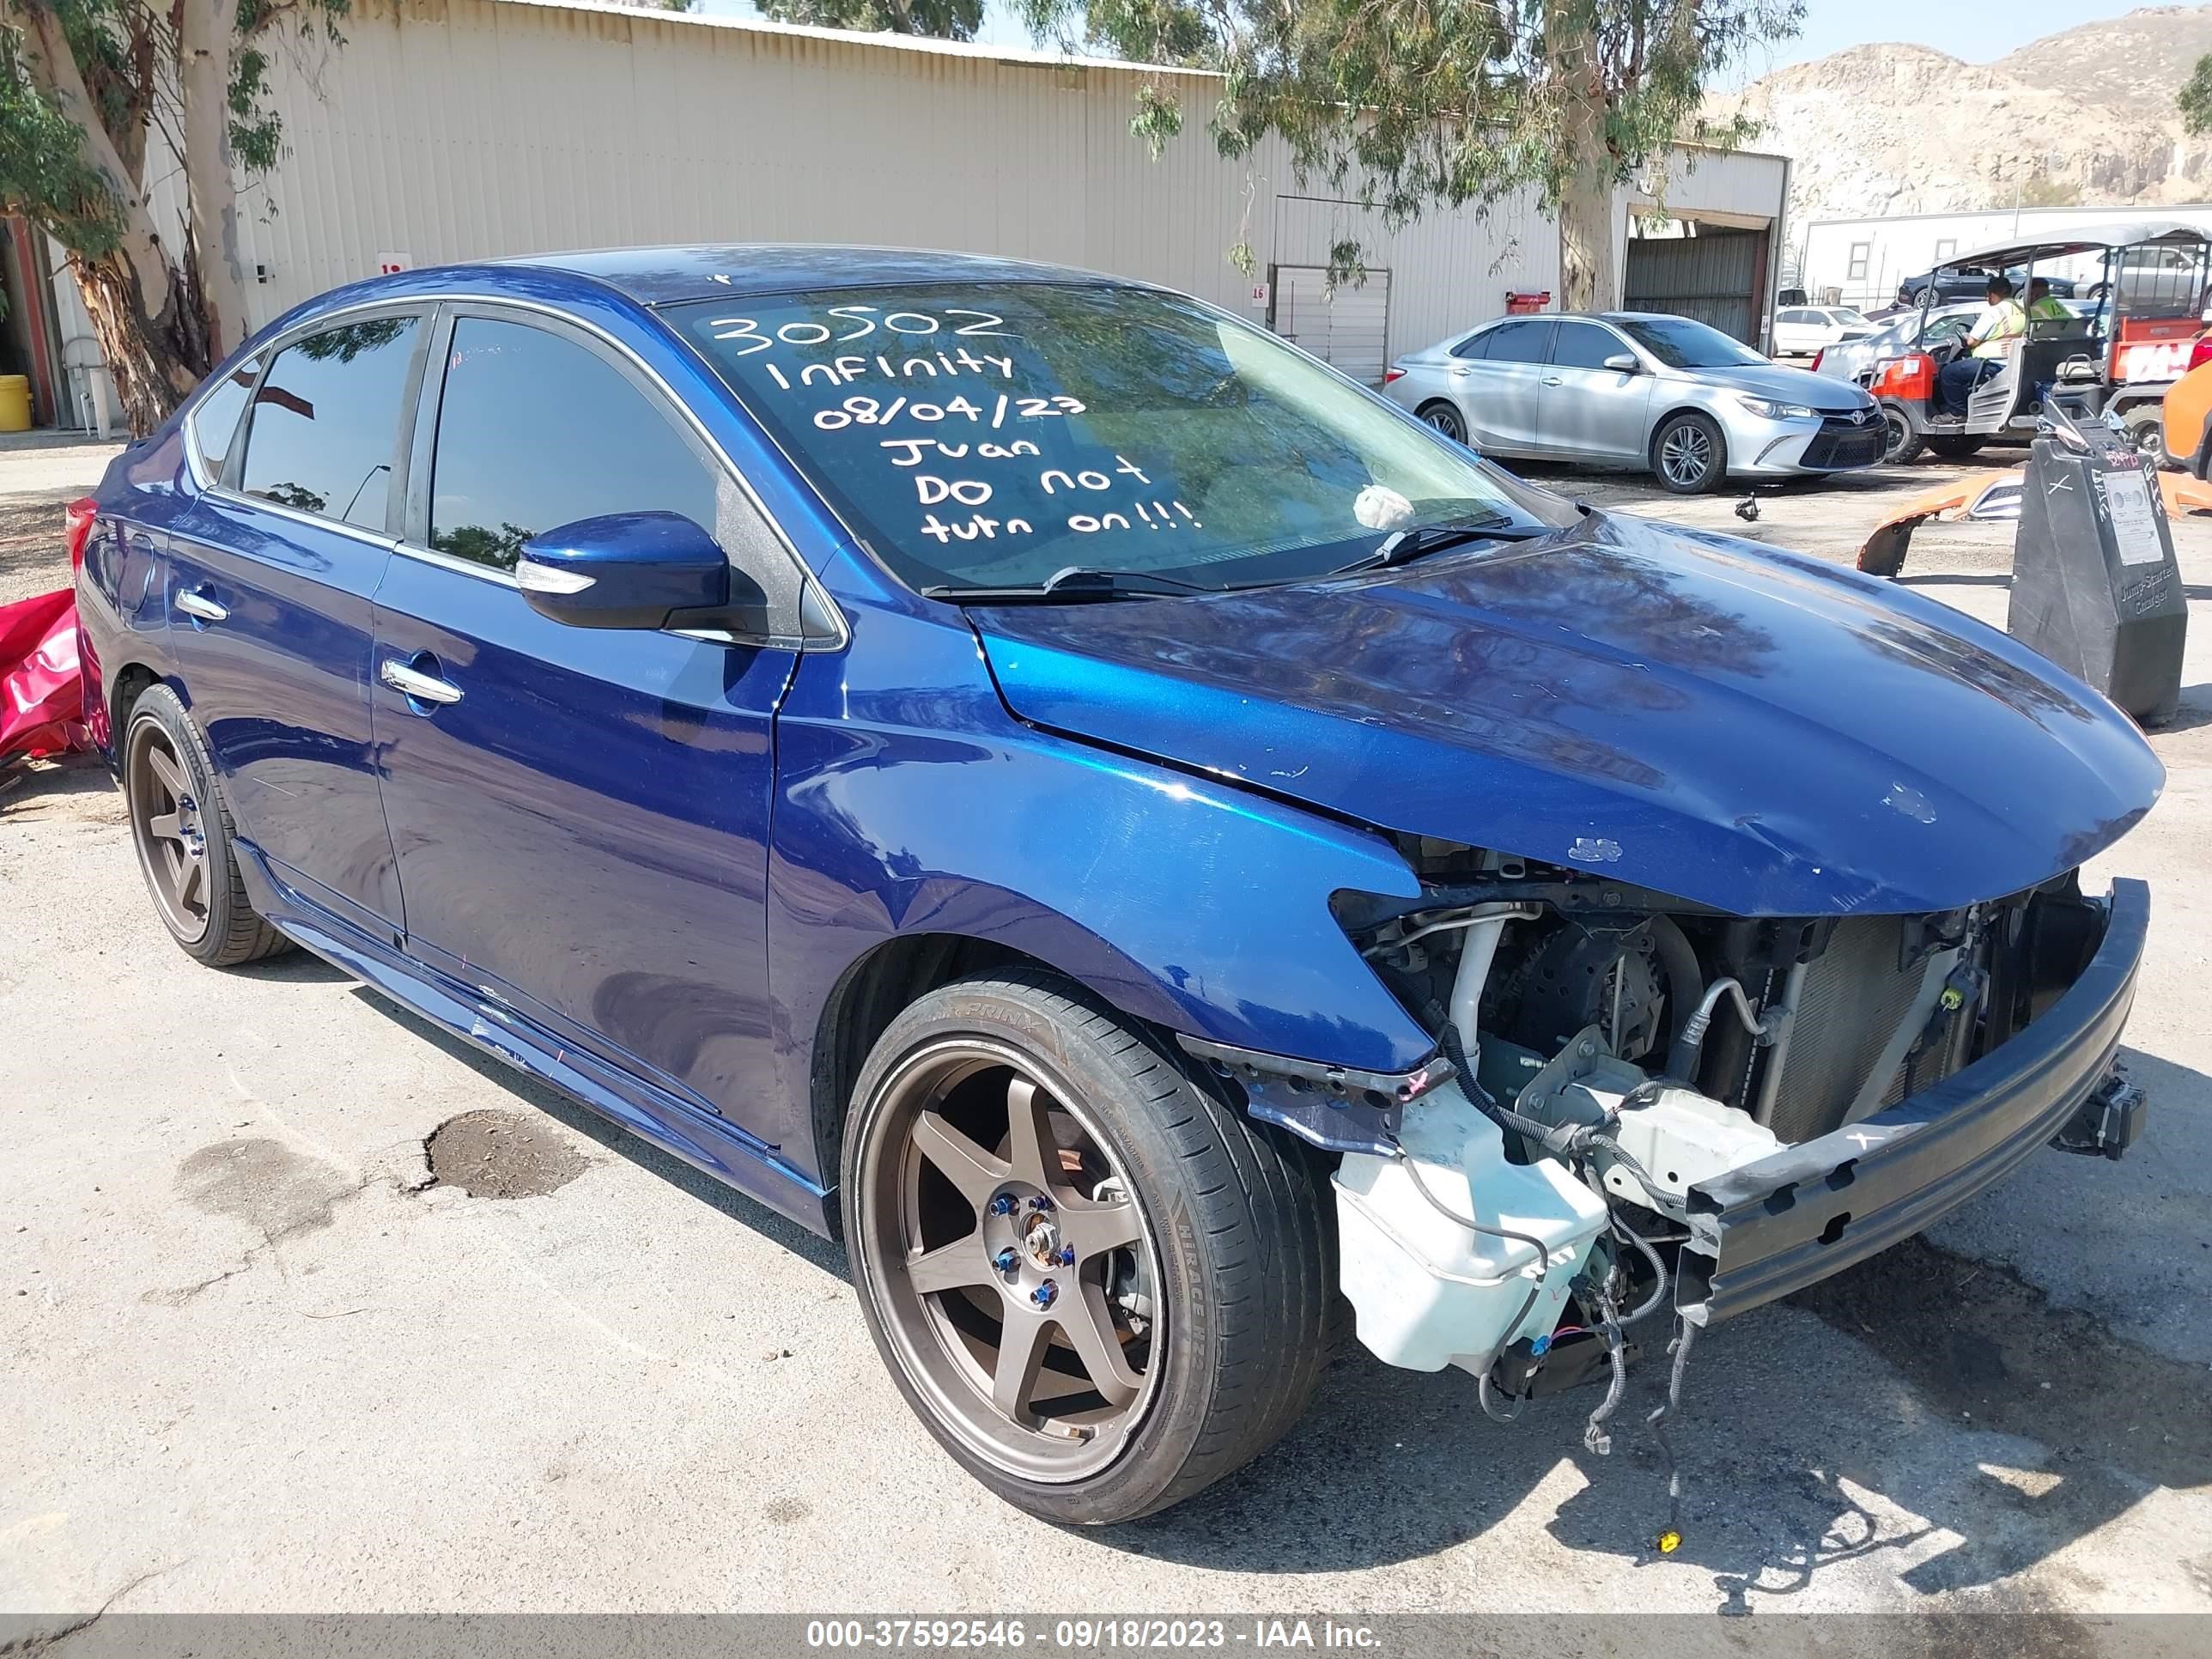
0,438 -> 2212,1627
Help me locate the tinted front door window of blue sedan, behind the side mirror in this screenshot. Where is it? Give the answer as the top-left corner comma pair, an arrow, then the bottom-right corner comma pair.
429,316 -> 717,571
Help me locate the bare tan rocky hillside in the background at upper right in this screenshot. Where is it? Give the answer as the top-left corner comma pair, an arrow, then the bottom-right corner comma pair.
1714,4 -> 2212,223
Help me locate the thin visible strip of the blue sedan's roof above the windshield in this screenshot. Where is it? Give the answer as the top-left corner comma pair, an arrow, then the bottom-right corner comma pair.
491,241 -> 1123,305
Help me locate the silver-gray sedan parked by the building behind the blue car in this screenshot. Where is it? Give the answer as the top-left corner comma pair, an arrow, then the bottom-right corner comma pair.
1382,312 -> 1882,495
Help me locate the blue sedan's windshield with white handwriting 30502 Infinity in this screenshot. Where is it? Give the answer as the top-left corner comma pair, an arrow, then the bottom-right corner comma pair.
665,283 -> 1573,588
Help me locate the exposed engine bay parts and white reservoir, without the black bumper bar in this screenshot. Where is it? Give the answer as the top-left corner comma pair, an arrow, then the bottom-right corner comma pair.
1212,841 -> 2139,1451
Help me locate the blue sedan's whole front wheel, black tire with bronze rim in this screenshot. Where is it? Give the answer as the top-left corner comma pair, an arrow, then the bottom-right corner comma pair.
841,969 -> 1336,1526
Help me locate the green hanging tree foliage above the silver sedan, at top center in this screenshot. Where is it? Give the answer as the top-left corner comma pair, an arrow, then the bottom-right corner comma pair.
1018,0 -> 1805,274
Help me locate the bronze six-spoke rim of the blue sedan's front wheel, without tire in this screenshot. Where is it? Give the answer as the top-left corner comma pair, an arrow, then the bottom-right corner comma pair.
854,1037 -> 1168,1484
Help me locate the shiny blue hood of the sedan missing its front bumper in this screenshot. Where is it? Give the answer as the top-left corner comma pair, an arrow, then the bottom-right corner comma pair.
969,514 -> 2163,915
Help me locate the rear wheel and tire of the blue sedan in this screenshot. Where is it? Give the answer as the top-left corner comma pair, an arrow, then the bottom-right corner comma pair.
122,686 -> 292,967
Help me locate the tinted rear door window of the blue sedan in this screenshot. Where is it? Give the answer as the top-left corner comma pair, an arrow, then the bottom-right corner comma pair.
239,316 -> 420,531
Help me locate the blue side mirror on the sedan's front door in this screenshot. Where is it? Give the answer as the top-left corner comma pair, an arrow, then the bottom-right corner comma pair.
515,514 -> 768,635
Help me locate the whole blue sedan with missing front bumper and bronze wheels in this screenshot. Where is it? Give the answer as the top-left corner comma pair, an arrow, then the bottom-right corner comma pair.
73,248 -> 2161,1522
